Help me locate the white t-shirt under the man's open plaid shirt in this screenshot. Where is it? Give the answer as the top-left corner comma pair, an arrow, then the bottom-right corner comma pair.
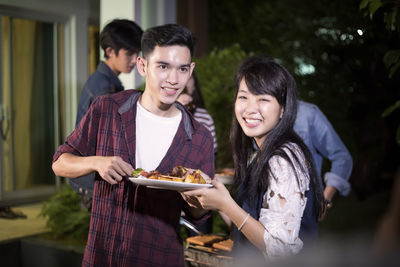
136,101 -> 182,171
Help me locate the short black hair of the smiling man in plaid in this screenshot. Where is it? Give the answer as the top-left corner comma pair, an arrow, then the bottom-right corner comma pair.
142,24 -> 195,58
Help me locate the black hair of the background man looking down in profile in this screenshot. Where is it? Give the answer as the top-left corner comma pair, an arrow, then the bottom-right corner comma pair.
100,19 -> 143,58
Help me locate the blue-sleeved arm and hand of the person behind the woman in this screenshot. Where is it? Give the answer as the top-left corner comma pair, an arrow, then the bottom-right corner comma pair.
310,105 -> 353,201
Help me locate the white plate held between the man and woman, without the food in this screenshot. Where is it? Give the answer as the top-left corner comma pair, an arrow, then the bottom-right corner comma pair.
129,176 -> 212,191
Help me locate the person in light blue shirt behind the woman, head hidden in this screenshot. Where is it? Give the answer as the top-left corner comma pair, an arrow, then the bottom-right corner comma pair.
294,101 -> 353,211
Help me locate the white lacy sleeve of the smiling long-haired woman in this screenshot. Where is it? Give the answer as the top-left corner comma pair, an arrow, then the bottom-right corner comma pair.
259,156 -> 309,258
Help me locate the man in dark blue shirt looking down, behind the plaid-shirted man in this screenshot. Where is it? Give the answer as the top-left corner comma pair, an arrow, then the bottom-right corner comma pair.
70,19 -> 143,210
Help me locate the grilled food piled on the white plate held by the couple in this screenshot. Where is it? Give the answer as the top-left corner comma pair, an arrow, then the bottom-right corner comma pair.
132,166 -> 206,184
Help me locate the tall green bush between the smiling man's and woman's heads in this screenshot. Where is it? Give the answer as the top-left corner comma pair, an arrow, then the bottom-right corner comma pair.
195,44 -> 249,168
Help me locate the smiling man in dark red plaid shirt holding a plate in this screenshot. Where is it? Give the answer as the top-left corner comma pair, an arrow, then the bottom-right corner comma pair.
52,24 -> 214,266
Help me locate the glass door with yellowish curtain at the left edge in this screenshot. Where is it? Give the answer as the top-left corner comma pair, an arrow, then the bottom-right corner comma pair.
0,16 -> 65,204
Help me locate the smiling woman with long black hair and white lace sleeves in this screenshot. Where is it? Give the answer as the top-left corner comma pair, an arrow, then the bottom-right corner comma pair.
183,56 -> 323,266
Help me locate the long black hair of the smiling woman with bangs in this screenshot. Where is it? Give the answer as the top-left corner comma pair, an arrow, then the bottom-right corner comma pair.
230,55 -> 324,220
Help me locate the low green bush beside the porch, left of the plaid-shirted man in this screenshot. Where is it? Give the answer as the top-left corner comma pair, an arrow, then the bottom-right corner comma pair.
39,185 -> 90,239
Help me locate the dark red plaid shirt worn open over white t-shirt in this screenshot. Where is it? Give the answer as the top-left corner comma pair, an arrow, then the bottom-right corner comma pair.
53,90 -> 214,266
